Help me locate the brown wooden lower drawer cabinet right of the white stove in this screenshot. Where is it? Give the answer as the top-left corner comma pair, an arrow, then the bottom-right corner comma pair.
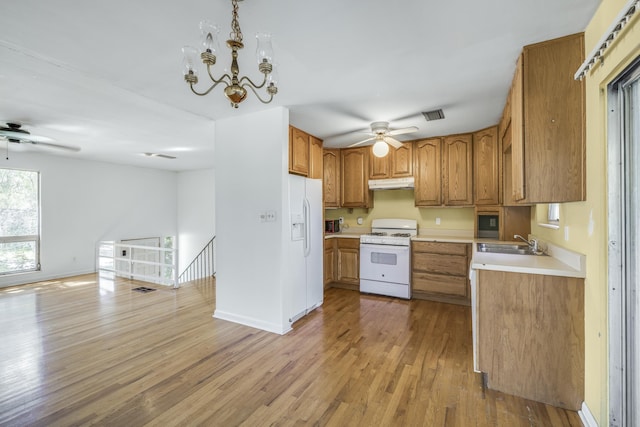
411,241 -> 471,305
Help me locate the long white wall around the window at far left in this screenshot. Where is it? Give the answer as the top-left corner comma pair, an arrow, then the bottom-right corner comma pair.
0,151 -> 177,287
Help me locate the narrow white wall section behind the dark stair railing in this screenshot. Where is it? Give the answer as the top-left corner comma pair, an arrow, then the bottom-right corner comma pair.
178,169 -> 216,273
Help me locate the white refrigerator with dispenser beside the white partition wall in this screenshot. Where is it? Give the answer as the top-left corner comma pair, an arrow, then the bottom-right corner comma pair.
285,175 -> 324,323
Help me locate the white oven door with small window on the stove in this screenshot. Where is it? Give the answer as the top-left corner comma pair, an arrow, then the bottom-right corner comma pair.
360,243 -> 410,286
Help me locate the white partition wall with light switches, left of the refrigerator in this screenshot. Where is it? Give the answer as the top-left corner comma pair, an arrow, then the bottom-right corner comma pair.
215,107 -> 289,333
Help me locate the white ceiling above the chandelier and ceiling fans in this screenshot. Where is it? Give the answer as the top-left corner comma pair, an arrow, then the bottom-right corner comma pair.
0,0 -> 599,170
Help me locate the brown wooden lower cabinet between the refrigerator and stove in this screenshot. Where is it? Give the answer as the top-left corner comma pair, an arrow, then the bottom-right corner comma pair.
324,237 -> 360,291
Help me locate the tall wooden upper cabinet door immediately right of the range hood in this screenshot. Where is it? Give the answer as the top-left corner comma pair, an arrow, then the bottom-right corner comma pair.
413,138 -> 442,206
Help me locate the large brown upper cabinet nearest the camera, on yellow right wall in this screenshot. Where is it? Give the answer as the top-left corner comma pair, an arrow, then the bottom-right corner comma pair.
501,34 -> 586,204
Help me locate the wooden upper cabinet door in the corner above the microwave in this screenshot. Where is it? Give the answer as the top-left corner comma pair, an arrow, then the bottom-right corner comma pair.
473,126 -> 502,205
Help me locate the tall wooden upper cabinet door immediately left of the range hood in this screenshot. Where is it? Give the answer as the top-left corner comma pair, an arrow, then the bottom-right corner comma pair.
340,147 -> 373,208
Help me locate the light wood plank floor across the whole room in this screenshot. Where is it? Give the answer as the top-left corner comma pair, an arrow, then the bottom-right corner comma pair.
0,275 -> 581,427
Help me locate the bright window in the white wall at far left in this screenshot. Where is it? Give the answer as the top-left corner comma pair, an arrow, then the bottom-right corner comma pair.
0,169 -> 40,274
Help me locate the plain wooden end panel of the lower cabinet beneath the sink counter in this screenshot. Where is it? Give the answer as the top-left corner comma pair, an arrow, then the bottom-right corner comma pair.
476,270 -> 584,411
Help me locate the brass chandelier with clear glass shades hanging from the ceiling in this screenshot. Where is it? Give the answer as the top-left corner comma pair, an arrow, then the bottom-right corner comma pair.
182,0 -> 278,108
